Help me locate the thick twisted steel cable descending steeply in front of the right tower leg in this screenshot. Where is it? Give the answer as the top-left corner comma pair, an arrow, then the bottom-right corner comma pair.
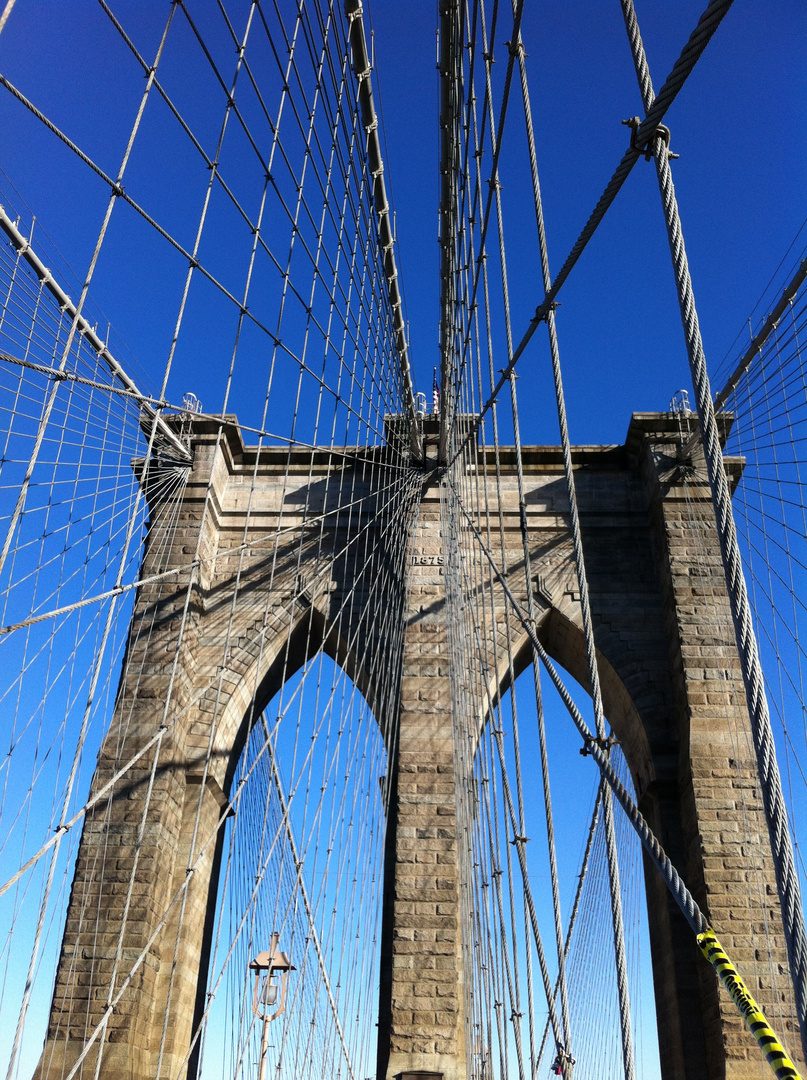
620,0 -> 807,1057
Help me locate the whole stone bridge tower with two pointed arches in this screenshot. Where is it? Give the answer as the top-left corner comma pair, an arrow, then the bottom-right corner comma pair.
37,414 -> 798,1080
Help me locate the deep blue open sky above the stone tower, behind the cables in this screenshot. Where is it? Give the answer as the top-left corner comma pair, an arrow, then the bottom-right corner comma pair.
0,0 -> 807,443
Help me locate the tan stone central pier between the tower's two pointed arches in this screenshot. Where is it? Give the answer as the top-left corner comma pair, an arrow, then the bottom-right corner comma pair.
378,483 -> 466,1080
